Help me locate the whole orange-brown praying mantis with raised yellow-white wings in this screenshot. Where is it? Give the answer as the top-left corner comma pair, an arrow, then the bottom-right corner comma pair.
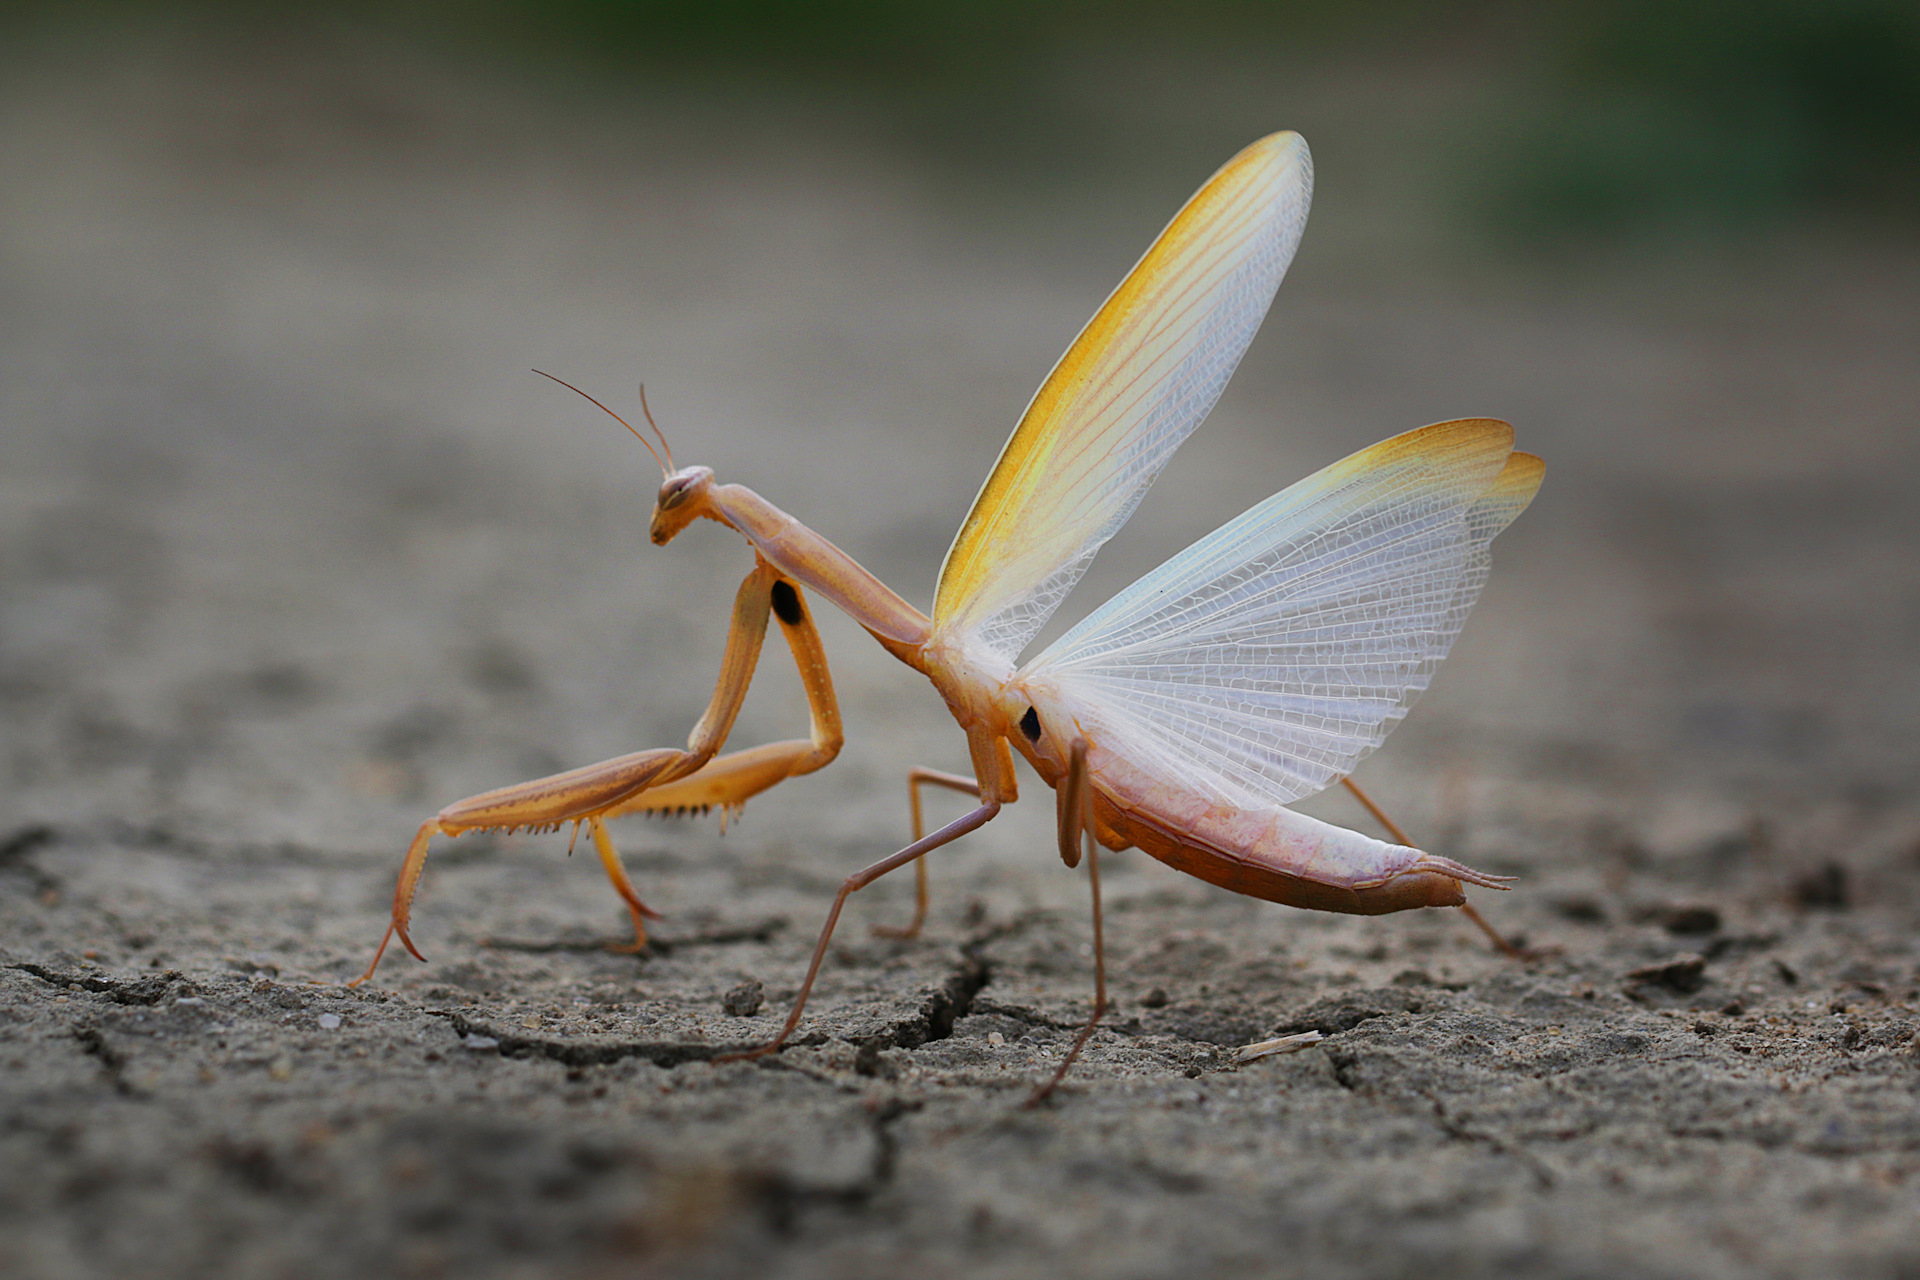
359,132 -> 1544,1096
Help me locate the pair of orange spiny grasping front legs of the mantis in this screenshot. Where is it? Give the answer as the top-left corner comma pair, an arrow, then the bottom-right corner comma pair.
351,560 -> 841,986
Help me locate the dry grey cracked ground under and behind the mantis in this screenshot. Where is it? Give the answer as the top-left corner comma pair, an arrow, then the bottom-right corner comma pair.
0,27 -> 1920,1280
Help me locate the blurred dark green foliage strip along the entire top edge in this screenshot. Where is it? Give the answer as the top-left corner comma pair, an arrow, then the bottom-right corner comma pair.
0,0 -> 1920,244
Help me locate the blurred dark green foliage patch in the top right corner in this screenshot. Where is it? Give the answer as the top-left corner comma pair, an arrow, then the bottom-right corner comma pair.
1496,0 -> 1920,238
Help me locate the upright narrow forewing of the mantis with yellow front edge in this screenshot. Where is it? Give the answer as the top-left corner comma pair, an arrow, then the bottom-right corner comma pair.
933,132 -> 1313,662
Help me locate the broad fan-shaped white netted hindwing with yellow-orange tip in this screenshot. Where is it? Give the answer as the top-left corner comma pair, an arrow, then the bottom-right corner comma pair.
1020,418 -> 1544,808
